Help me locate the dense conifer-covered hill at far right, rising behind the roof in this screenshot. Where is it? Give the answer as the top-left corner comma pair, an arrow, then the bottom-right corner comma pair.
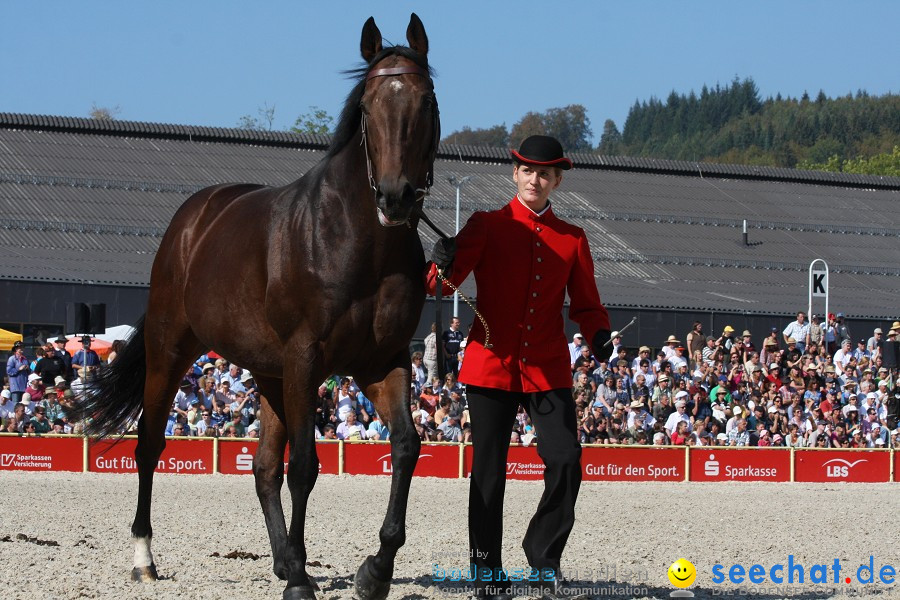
598,79 -> 900,168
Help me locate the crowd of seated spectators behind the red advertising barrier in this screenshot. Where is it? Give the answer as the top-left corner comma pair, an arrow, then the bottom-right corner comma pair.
0,312 -> 900,448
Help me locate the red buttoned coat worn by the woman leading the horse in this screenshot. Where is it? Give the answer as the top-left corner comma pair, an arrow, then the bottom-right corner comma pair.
426,198 -> 610,392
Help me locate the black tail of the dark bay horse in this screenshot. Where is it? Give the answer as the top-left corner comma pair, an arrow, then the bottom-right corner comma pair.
71,317 -> 147,438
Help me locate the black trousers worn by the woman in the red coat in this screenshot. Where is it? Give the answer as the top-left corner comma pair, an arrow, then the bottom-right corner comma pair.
466,385 -> 581,594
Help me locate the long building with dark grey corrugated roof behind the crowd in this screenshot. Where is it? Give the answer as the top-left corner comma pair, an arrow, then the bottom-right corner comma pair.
0,113 -> 900,346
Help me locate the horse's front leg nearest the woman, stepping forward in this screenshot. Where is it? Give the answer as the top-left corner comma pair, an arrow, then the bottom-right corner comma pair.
354,356 -> 421,600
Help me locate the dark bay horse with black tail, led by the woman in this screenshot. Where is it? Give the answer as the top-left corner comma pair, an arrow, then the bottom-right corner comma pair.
70,14 -> 440,600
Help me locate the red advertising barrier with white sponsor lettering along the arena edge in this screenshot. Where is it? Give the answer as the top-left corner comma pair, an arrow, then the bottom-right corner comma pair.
0,435 -> 900,483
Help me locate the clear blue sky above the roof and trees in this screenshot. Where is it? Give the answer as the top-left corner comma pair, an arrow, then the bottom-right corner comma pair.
0,0 -> 900,141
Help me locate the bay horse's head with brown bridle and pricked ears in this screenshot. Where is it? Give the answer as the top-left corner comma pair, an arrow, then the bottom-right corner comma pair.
360,13 -> 440,225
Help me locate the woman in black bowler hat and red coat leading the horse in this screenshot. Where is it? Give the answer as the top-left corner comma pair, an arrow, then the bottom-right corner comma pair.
426,136 -> 610,598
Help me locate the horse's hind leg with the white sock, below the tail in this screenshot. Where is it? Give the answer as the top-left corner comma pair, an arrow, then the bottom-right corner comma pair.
131,322 -> 202,581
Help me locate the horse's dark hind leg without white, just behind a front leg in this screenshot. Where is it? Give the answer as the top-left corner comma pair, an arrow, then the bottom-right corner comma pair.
253,376 -> 288,579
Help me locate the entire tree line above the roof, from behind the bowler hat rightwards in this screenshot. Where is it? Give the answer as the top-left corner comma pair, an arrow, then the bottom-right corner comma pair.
432,78 -> 900,176
